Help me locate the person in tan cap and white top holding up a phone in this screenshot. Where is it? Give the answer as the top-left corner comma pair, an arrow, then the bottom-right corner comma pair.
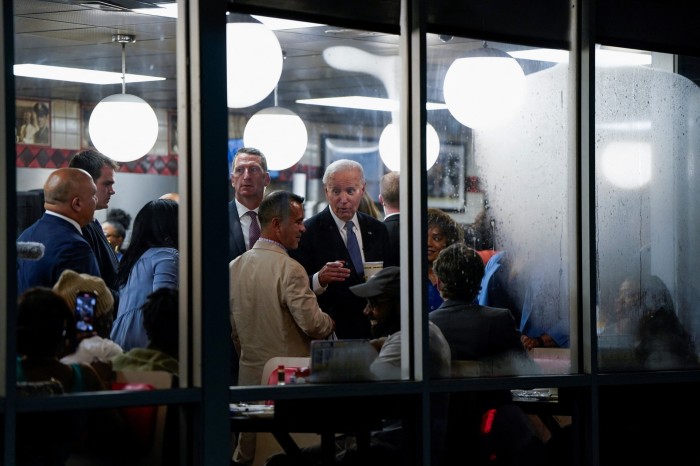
53,270 -> 123,364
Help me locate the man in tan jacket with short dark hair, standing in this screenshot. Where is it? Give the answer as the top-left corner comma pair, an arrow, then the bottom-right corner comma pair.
229,191 -> 334,464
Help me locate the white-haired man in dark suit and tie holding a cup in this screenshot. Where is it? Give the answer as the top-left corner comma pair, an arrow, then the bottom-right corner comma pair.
289,159 -> 394,338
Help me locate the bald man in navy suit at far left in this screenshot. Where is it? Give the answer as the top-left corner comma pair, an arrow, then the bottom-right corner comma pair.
17,168 -> 100,294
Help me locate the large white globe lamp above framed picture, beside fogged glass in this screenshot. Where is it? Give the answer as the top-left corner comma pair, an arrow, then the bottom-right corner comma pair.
443,45 -> 525,129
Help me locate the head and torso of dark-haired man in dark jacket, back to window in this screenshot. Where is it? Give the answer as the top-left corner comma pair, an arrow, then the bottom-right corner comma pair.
428,243 -> 532,371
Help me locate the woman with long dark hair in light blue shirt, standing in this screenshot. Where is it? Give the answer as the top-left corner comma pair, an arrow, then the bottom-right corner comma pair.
110,199 -> 180,351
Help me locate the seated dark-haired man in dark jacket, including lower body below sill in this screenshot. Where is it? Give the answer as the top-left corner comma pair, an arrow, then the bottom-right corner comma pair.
428,243 -> 545,464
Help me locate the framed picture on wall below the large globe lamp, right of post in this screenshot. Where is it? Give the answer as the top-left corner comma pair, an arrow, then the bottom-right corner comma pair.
428,144 -> 467,212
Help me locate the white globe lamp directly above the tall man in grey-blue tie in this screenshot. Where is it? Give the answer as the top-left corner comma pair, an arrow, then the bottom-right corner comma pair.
243,107 -> 309,170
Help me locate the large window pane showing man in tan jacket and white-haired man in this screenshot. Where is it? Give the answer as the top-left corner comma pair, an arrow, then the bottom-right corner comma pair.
227,13 -> 407,385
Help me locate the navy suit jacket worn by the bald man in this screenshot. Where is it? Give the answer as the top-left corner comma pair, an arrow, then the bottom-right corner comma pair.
17,213 -> 100,293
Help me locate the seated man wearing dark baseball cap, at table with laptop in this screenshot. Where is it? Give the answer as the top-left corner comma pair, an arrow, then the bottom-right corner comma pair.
266,267 -> 450,466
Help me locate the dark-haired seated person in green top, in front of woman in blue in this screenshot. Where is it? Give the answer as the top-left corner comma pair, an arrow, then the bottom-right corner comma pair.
112,288 -> 179,375
